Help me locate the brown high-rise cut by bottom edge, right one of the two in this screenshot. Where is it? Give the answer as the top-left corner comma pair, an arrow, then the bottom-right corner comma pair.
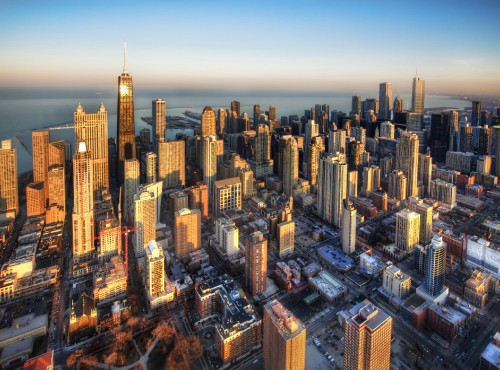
344,300 -> 392,370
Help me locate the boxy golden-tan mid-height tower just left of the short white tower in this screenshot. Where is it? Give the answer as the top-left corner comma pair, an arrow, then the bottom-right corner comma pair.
174,208 -> 201,258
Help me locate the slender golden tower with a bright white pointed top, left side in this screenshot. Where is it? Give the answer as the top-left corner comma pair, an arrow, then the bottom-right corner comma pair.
73,142 -> 94,263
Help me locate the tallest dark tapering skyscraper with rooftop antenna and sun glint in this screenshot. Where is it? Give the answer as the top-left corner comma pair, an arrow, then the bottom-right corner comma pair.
115,54 -> 136,185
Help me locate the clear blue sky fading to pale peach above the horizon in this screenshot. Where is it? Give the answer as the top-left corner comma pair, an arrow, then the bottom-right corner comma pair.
0,0 -> 500,96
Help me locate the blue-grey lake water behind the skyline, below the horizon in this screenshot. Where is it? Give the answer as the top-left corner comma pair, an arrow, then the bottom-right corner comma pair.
0,89 -> 470,173
